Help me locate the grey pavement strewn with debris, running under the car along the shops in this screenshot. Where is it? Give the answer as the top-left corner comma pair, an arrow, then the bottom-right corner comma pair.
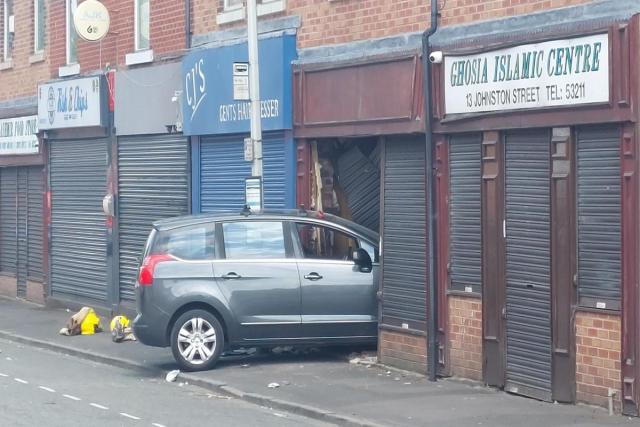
0,298 -> 640,427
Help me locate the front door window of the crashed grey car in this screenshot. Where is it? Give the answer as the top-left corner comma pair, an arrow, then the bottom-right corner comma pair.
296,222 -> 358,261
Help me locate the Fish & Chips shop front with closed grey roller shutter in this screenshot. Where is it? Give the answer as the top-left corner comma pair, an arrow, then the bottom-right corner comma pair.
38,76 -> 115,307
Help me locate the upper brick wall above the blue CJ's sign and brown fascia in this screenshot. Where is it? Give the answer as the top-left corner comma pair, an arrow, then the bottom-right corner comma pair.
193,0 -> 592,48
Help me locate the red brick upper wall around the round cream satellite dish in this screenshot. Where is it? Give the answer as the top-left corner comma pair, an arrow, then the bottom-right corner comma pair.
49,0 -> 185,77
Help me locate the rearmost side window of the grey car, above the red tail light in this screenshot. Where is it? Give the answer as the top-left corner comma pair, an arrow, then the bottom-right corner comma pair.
151,225 -> 215,261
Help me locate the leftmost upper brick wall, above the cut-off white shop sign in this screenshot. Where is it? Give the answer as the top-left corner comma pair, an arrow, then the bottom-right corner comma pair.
0,0 -> 49,101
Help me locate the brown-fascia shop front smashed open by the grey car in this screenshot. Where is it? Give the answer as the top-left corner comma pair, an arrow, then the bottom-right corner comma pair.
294,45 -> 428,372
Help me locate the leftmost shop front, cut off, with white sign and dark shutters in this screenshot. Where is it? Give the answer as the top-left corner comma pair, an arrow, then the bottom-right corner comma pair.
0,115 -> 45,303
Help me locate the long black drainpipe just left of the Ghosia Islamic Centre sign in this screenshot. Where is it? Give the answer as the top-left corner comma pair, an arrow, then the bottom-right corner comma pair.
422,0 -> 438,381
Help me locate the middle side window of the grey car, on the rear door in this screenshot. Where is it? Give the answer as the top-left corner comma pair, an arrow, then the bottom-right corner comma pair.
222,221 -> 286,259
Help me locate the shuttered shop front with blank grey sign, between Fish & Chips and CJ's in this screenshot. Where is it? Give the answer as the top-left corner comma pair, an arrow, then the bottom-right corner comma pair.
113,63 -> 190,305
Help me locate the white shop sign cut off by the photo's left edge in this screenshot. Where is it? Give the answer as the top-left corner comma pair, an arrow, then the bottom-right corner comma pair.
0,116 -> 38,156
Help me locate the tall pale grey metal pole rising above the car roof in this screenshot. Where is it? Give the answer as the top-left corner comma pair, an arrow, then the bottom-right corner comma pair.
247,0 -> 263,194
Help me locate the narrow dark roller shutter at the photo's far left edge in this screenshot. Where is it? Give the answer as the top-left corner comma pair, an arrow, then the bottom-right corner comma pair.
0,168 -> 18,273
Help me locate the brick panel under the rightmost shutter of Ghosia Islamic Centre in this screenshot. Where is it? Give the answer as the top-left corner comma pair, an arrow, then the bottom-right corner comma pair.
576,312 -> 621,411
